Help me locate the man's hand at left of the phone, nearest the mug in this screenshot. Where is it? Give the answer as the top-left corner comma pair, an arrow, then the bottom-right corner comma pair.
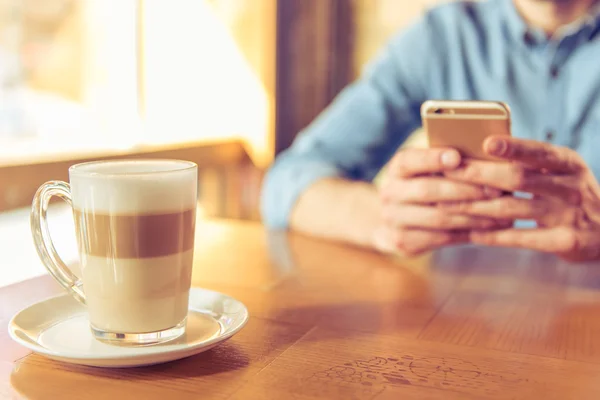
374,148 -> 511,256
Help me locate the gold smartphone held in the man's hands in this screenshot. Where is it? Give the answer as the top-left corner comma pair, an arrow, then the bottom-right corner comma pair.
421,100 -> 511,160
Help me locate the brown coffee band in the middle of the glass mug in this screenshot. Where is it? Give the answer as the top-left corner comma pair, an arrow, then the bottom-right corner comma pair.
73,208 -> 196,258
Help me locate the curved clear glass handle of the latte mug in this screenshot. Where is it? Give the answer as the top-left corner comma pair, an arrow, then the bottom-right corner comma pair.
30,181 -> 85,304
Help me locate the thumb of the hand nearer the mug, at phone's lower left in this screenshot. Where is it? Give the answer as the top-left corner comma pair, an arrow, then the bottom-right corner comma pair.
389,148 -> 461,178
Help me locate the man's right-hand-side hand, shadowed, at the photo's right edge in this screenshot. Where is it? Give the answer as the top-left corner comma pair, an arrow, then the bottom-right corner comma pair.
442,137 -> 600,261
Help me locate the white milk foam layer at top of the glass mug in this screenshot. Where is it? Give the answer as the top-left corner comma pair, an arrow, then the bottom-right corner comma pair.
69,160 -> 198,215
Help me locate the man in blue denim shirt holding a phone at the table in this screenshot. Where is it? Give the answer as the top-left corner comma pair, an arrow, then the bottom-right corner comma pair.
262,0 -> 600,260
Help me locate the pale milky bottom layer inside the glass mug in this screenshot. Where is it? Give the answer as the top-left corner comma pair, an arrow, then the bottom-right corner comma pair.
82,250 -> 194,333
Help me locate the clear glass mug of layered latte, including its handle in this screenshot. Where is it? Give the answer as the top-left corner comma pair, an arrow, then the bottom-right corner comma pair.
31,160 -> 198,345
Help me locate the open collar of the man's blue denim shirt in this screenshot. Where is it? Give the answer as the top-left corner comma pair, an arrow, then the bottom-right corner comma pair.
500,0 -> 600,45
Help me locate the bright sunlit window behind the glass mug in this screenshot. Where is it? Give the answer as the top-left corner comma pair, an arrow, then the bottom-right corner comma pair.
0,0 -> 275,164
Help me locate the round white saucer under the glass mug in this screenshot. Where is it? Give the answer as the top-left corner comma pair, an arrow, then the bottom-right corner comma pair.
8,288 -> 248,368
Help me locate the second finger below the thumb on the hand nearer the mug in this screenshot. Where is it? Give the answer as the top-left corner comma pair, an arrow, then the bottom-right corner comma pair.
383,204 -> 511,230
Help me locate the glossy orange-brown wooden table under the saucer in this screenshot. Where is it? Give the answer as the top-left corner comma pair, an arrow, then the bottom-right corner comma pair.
0,221 -> 600,400
